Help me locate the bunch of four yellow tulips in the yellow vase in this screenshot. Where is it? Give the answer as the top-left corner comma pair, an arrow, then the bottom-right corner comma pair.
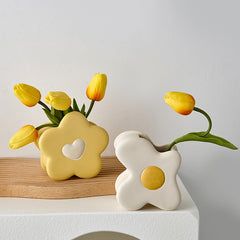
9,73 -> 107,149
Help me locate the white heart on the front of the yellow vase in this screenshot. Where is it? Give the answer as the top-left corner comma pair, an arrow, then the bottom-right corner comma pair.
62,138 -> 85,160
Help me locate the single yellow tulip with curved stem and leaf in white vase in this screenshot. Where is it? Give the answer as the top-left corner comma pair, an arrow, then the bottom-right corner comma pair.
164,92 -> 238,151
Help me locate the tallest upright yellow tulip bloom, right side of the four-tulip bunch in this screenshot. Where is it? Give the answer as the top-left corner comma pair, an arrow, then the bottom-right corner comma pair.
86,73 -> 107,101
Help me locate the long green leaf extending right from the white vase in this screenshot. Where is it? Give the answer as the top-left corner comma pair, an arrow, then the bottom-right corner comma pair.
174,132 -> 238,150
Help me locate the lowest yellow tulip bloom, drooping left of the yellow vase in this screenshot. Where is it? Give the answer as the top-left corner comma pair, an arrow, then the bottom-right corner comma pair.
9,125 -> 38,149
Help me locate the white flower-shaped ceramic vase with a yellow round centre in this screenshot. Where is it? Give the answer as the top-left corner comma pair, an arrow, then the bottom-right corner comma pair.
114,131 -> 181,210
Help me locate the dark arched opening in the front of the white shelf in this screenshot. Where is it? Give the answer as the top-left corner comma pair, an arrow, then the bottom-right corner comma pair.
73,232 -> 139,240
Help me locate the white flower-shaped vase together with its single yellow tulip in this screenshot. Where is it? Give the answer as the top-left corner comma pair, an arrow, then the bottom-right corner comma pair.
114,92 -> 237,210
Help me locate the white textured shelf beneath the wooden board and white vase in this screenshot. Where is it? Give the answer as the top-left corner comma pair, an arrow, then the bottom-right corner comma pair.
0,179 -> 199,240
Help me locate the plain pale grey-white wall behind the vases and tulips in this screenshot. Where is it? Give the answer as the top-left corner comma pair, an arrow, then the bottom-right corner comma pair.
0,0 -> 240,240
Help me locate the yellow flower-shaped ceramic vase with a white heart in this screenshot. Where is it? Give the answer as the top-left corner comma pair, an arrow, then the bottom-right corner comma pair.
37,112 -> 108,180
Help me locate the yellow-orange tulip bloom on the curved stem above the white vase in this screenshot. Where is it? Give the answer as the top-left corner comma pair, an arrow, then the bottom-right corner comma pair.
164,92 -> 195,115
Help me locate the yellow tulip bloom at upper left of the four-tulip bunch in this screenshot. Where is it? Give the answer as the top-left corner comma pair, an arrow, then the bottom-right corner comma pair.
14,83 -> 41,107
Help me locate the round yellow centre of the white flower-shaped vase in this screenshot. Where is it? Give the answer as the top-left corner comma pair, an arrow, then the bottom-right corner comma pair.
141,166 -> 165,190
